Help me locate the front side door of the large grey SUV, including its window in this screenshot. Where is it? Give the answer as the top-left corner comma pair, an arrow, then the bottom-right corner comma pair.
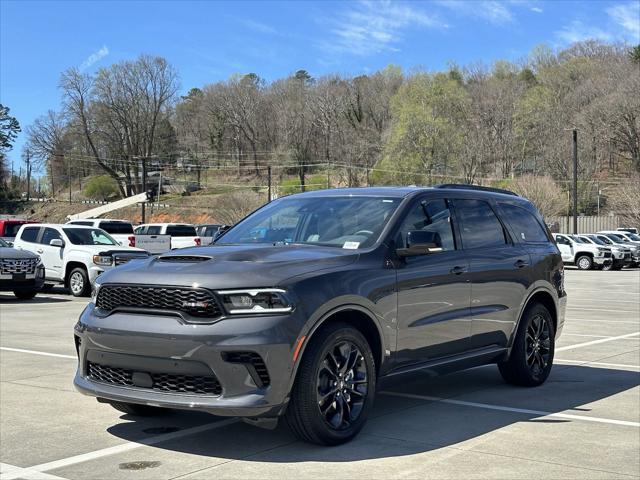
396,199 -> 471,366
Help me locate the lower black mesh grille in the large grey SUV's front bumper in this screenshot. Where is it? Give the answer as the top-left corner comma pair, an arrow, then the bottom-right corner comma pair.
87,362 -> 222,396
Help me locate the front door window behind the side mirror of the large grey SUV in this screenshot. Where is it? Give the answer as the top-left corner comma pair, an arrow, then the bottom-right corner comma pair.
399,200 -> 456,250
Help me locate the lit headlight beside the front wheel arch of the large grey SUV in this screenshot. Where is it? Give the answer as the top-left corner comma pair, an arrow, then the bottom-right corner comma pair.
217,288 -> 293,315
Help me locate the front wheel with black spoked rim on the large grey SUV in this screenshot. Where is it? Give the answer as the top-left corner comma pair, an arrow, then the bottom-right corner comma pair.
285,323 -> 376,445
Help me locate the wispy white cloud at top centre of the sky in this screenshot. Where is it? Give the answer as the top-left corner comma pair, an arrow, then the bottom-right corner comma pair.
320,1 -> 448,56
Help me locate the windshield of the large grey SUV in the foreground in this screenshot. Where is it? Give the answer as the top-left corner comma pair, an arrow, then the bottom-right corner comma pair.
216,197 -> 401,249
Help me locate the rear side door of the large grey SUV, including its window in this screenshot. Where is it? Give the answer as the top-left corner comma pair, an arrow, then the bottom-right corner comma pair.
454,198 -> 532,348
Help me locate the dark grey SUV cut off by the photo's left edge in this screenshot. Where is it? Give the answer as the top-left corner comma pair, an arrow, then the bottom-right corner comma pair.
0,238 -> 44,300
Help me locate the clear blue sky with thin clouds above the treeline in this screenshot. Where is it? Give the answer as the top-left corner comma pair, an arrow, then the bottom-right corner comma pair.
0,0 -> 640,170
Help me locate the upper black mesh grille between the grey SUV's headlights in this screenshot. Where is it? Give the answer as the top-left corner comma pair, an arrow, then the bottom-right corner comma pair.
96,284 -> 222,323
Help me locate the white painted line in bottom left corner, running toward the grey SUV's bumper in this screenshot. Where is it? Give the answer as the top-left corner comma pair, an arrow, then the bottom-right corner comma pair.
2,418 -> 239,480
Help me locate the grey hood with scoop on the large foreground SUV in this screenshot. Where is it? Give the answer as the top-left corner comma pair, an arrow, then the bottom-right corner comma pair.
100,245 -> 358,289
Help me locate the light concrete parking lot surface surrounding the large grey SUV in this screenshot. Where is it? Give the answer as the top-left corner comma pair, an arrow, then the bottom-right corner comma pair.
0,269 -> 640,480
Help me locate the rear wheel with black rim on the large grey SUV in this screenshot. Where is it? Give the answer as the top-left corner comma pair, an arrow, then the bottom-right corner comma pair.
498,304 -> 555,387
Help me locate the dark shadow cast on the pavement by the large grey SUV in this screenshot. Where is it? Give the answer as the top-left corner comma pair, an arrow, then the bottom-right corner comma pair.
108,365 -> 640,463
